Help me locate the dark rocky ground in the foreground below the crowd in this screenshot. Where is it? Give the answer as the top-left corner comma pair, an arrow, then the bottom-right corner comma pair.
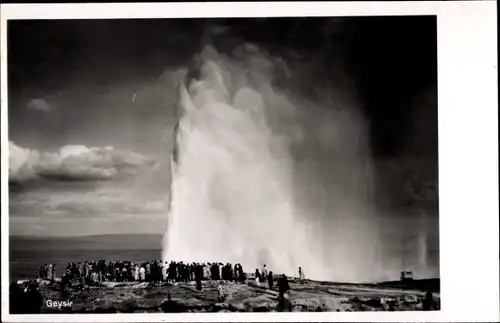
11,281 -> 440,313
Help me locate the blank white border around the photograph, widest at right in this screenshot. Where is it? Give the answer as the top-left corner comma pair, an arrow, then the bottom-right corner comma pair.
0,1 -> 500,322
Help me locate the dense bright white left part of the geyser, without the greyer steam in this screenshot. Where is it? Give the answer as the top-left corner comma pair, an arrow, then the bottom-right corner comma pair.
163,49 -> 312,273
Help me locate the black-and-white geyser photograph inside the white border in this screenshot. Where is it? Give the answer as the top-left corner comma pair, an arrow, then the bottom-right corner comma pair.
2,1 -> 496,322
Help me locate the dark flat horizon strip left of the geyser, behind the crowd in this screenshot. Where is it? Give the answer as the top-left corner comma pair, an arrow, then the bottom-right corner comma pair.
9,235 -> 162,280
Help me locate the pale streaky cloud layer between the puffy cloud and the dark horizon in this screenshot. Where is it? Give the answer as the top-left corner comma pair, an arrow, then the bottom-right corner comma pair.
9,182 -> 168,236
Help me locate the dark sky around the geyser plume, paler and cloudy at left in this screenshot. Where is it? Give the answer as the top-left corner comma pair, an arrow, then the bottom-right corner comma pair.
7,16 -> 437,235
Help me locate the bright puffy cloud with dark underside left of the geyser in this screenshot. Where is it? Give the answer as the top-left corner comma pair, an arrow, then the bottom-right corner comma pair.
9,142 -> 153,182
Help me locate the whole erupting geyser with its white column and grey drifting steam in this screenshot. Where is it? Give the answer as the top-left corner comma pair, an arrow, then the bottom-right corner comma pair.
163,45 -> 385,282
